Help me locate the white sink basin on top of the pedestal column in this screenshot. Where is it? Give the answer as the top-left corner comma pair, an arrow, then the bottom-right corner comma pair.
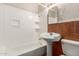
40,32 -> 61,42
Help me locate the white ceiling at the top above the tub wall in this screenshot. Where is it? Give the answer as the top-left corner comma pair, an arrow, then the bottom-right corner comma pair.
6,3 -> 54,13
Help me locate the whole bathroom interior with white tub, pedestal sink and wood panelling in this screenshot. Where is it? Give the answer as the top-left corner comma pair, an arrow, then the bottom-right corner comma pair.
0,3 -> 79,56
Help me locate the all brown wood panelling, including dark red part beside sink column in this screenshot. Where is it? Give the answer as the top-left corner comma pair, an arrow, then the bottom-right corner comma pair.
48,21 -> 79,56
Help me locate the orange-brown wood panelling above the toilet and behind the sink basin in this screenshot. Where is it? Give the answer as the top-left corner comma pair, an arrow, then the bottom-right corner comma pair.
48,21 -> 79,41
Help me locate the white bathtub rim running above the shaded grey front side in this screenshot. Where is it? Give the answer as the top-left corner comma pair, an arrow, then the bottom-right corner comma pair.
6,43 -> 47,56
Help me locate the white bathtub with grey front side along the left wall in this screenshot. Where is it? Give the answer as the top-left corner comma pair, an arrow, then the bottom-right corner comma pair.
0,46 -> 47,56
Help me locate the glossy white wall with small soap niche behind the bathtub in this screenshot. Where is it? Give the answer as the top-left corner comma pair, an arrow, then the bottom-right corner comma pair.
0,4 -> 42,55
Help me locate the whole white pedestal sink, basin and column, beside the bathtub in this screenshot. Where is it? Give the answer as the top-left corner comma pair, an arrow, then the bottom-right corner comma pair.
40,32 -> 61,56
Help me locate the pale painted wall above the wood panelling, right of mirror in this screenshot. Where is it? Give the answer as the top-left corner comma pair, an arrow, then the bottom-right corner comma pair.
58,3 -> 79,22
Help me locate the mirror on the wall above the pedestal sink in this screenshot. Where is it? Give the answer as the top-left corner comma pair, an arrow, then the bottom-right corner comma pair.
47,6 -> 58,24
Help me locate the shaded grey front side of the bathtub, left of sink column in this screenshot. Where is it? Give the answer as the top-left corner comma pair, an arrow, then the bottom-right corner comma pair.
19,46 -> 46,56
